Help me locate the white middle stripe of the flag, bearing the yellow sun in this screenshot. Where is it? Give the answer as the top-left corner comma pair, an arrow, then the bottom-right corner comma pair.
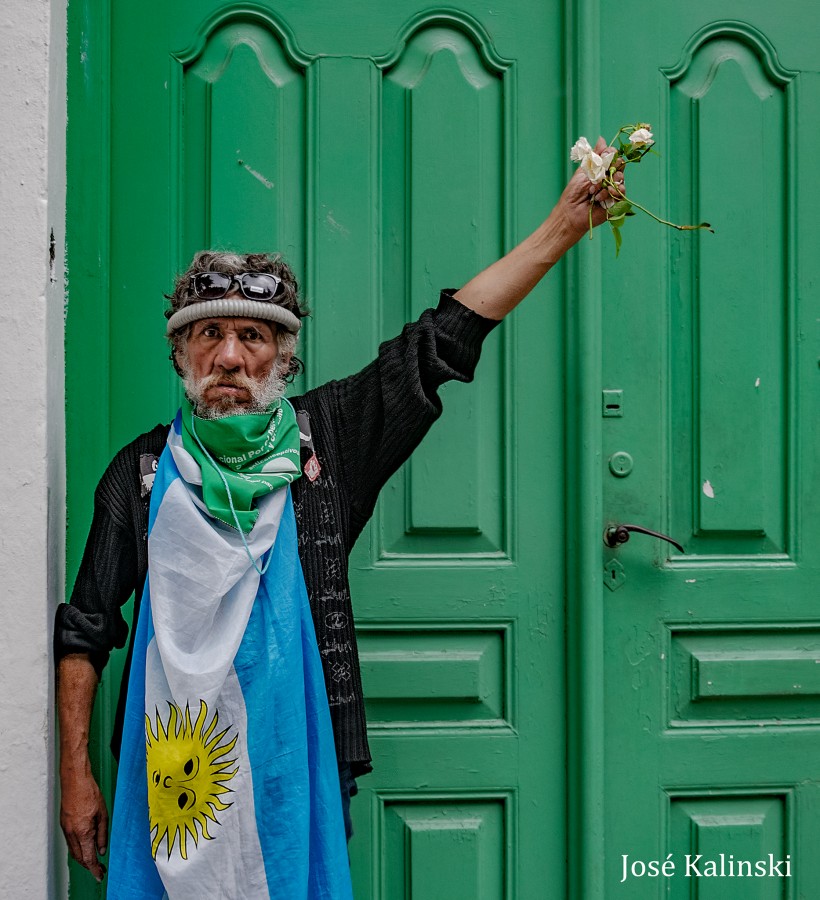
145,432 -> 287,900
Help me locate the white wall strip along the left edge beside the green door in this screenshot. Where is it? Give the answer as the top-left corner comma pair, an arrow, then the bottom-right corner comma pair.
0,0 -> 66,900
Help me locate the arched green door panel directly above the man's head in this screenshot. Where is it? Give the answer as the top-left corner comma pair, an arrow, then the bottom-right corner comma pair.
179,20 -> 307,271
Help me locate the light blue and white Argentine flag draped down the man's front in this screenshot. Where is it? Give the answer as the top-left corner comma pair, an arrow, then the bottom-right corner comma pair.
108,416 -> 353,900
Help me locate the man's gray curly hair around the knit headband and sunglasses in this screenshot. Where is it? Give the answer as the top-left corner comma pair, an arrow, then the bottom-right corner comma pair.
165,250 -> 309,381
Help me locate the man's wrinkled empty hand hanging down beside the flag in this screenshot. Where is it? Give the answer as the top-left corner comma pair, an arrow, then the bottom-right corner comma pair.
60,774 -> 108,881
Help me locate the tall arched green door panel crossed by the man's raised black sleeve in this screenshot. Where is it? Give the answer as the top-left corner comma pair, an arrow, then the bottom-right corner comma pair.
379,21 -> 512,560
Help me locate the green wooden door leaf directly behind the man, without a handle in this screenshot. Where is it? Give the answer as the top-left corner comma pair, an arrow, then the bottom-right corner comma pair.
67,0 -> 567,900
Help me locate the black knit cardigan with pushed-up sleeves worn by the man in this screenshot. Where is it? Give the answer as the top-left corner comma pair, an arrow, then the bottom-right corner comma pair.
54,291 -> 497,775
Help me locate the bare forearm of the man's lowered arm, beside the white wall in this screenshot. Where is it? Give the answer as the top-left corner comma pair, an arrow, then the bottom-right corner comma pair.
57,653 -> 97,777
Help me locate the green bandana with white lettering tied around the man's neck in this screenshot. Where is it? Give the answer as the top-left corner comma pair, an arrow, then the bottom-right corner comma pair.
182,399 -> 301,533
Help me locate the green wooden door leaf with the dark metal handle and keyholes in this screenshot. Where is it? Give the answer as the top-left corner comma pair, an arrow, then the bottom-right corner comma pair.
584,7 -> 820,900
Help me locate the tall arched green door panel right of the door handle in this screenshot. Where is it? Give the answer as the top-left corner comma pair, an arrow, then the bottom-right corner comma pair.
664,26 -> 797,562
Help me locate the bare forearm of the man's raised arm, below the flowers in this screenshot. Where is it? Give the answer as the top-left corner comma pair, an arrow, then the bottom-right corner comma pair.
454,208 -> 580,320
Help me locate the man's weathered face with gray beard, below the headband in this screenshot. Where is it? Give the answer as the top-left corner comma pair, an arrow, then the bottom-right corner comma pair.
180,318 -> 290,415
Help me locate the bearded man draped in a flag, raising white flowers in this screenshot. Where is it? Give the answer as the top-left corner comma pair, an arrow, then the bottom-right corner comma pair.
55,140 -> 622,900
